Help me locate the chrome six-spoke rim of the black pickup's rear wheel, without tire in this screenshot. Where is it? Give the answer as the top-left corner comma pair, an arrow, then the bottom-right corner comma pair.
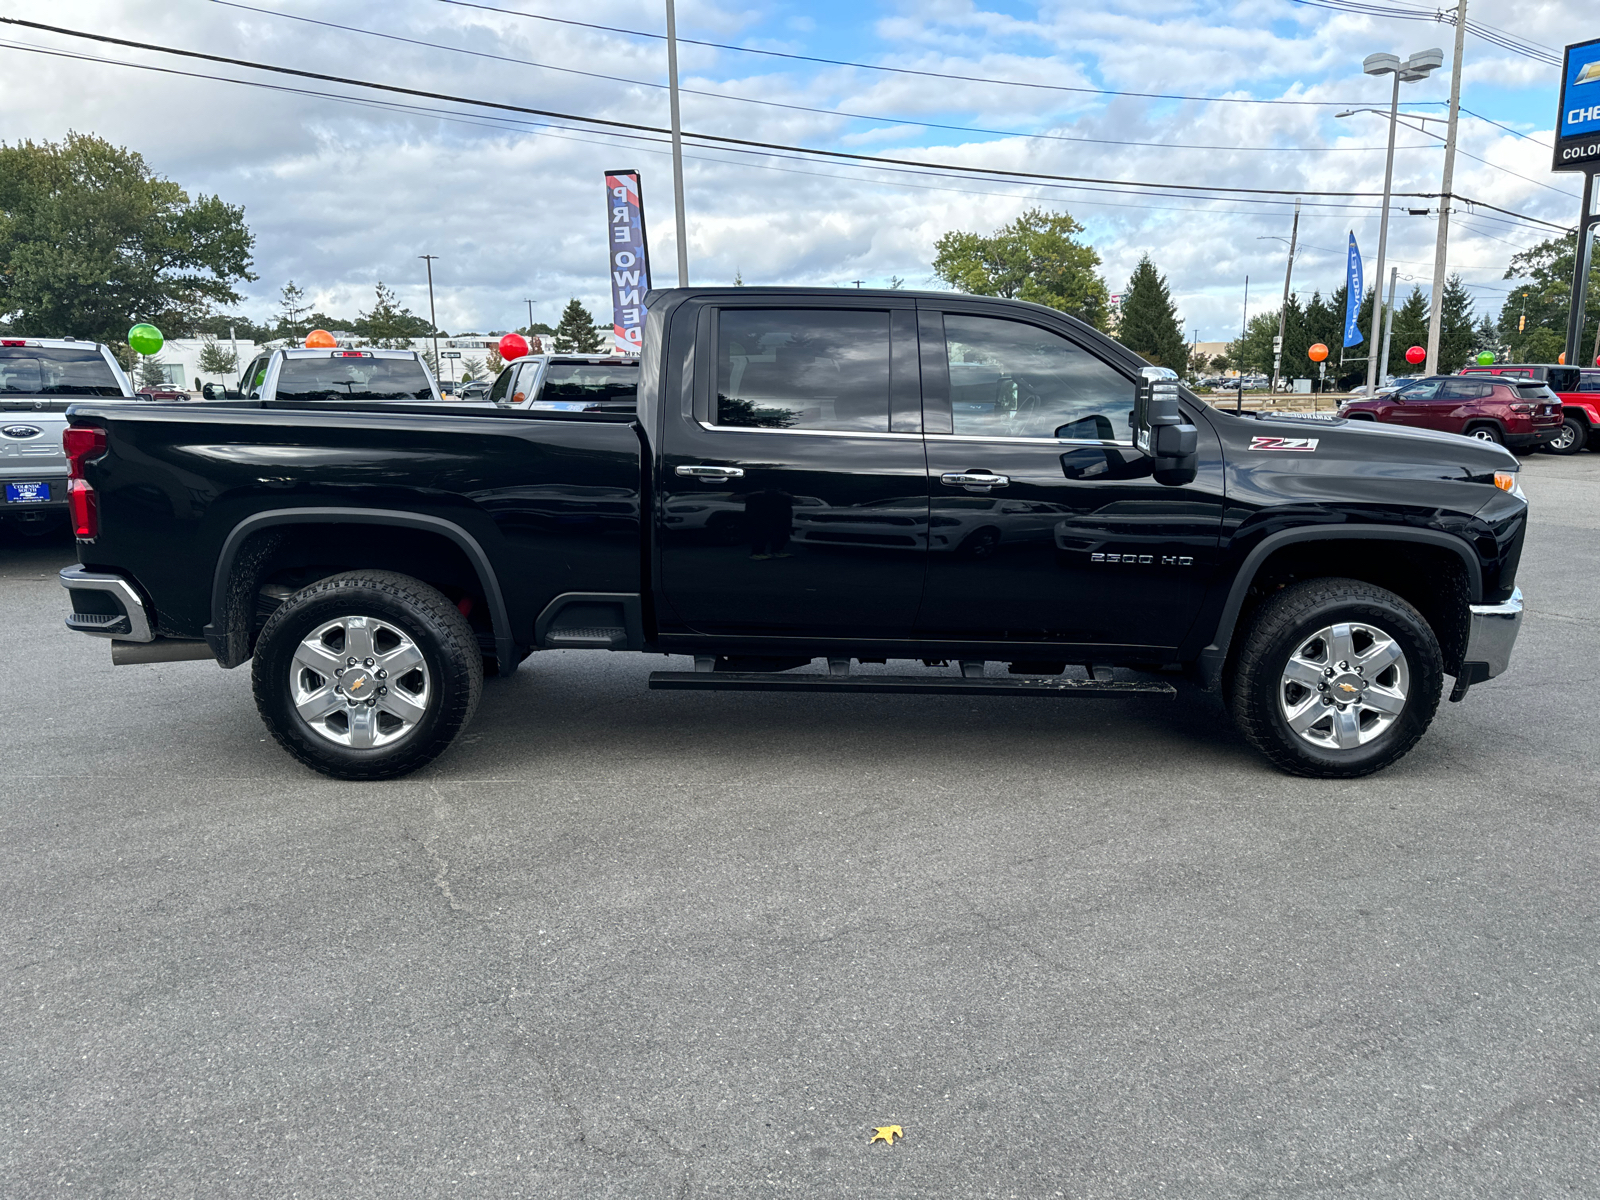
290,616 -> 432,750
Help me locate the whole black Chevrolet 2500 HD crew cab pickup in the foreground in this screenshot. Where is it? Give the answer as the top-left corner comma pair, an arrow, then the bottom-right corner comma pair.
62,288 -> 1528,779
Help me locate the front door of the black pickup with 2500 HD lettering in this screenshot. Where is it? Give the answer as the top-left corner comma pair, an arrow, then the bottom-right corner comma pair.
917,302 -> 1222,661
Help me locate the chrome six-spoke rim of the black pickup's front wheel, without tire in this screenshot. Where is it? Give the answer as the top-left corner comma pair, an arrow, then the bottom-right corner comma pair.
1278,622 -> 1411,750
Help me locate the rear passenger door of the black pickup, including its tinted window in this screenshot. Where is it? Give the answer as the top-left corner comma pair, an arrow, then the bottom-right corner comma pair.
656,301 -> 928,638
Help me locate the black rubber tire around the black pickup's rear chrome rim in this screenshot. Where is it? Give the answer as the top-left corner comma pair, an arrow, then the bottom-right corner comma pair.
251,571 -> 483,779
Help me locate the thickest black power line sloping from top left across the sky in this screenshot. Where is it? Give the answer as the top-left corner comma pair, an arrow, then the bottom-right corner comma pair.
0,16 -> 1566,232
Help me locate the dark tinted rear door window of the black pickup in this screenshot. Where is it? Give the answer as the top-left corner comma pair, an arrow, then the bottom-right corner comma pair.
714,309 -> 890,434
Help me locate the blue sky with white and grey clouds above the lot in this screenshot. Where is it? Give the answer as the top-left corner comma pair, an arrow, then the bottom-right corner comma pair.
0,0 -> 1600,341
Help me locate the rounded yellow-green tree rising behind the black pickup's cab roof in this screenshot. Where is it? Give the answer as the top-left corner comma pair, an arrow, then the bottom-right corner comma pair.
933,208 -> 1110,330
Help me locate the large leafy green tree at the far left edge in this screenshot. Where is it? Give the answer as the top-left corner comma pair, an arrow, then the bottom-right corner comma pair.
0,133 -> 256,342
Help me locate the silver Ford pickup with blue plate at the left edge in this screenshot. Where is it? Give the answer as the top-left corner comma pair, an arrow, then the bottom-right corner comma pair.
0,338 -> 134,534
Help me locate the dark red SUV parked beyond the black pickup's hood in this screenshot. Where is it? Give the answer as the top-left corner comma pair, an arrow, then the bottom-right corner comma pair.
1339,374 -> 1563,450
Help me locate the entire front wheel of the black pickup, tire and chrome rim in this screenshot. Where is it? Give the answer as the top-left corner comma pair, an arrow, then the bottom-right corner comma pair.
1232,579 -> 1445,779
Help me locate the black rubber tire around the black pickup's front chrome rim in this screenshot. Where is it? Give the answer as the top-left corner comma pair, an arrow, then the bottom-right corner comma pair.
1229,579 -> 1445,779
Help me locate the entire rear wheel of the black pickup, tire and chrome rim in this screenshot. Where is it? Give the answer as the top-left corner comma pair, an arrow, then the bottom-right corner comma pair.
251,571 -> 483,779
